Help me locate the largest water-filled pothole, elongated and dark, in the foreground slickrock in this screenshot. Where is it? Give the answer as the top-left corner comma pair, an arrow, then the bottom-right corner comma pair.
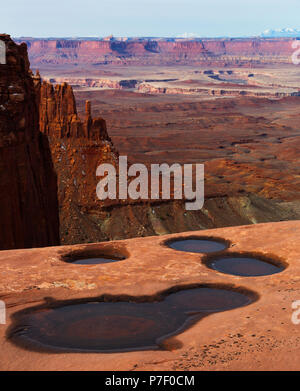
8,286 -> 257,352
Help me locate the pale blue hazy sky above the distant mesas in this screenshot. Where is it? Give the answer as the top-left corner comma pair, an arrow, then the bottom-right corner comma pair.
0,0 -> 300,37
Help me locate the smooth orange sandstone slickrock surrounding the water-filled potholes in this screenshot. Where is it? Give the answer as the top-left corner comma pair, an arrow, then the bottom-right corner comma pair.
0,221 -> 300,371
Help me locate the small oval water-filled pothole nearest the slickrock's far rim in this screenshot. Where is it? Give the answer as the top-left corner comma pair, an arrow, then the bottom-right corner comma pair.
166,236 -> 229,254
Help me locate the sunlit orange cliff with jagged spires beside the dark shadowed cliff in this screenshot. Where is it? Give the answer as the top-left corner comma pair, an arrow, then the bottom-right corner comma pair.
34,74 -> 118,243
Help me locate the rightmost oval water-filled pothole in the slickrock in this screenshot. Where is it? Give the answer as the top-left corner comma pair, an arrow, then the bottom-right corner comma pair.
204,253 -> 285,277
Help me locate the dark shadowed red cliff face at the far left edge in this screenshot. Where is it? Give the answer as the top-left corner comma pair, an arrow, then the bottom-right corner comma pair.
0,35 -> 59,250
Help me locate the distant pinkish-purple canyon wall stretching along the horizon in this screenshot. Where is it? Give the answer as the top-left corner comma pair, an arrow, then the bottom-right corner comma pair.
17,38 -> 295,66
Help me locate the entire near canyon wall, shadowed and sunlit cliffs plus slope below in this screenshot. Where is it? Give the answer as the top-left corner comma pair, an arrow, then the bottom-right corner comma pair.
0,35 -> 299,249
